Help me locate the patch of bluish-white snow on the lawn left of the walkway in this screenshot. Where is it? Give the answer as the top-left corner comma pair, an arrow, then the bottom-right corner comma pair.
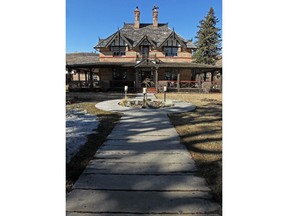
66,109 -> 99,163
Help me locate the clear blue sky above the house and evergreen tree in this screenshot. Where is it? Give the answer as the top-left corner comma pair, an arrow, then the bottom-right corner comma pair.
66,0 -> 222,53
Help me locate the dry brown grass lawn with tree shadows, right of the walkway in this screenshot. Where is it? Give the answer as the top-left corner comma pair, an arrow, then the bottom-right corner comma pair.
157,93 -> 222,204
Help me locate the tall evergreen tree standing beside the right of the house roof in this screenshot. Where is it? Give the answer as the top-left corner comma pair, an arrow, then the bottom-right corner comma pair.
194,7 -> 222,65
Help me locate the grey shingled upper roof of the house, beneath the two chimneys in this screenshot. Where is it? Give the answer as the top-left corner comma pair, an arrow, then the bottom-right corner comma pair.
94,23 -> 196,48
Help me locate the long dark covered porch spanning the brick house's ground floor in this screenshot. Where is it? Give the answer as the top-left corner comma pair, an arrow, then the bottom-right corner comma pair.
66,55 -> 222,93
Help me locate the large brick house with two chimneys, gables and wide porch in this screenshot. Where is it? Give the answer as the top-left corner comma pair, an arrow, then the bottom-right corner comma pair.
66,7 -> 222,92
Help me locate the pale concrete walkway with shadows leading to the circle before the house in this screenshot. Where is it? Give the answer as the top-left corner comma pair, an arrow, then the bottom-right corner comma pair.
66,95 -> 220,216
